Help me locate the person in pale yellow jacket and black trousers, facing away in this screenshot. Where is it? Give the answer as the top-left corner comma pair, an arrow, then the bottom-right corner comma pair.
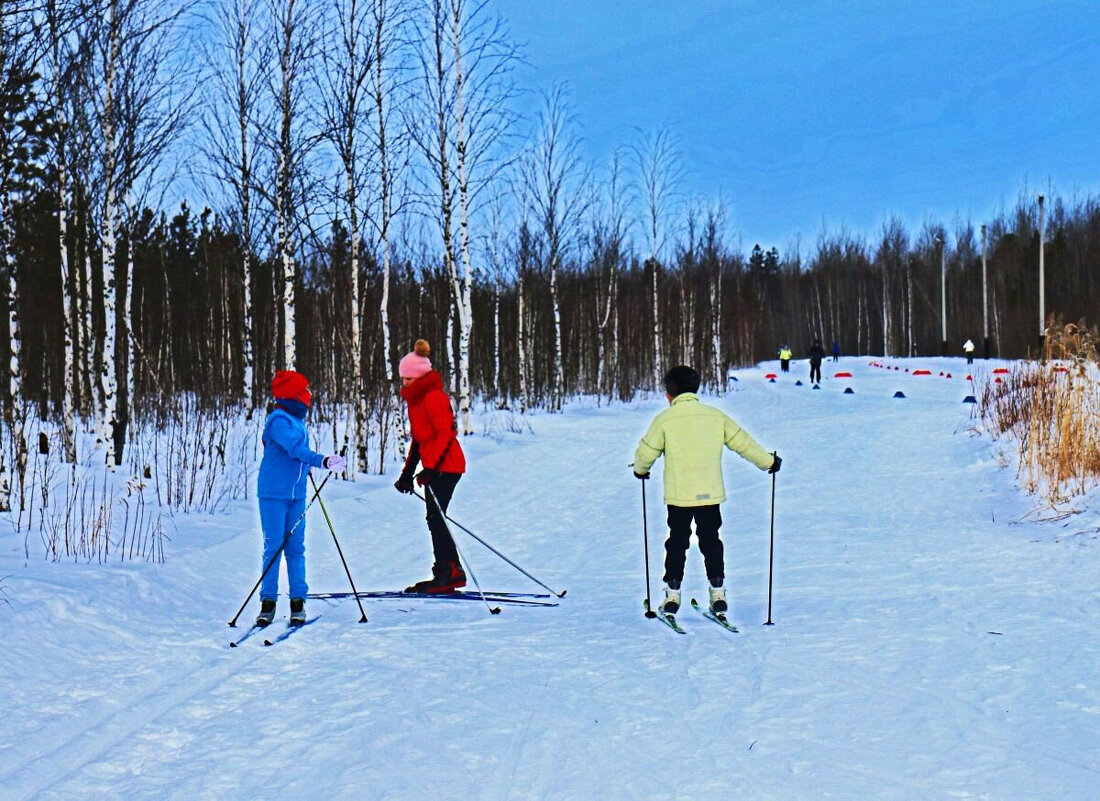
634,365 -> 782,614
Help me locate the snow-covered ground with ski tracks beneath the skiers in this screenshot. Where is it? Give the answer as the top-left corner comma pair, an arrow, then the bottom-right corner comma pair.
0,359 -> 1100,801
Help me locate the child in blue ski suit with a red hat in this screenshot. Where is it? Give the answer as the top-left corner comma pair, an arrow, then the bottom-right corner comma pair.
256,370 -> 348,626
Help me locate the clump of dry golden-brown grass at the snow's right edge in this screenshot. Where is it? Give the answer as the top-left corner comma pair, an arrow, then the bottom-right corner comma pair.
978,321 -> 1100,506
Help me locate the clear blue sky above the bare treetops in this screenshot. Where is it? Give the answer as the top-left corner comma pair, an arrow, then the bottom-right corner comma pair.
494,0 -> 1100,250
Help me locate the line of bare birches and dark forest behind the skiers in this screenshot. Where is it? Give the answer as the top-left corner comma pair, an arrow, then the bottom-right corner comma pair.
0,0 -> 1100,506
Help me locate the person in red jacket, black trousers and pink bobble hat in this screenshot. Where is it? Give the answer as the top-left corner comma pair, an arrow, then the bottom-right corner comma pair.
394,339 -> 466,593
